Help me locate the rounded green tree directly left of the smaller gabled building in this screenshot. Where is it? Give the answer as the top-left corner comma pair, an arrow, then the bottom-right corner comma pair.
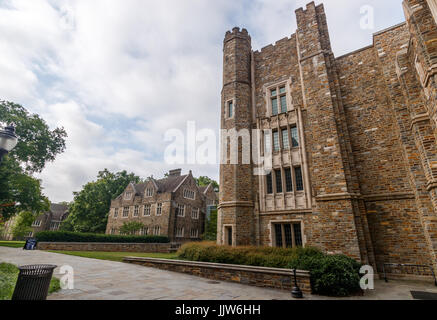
61,169 -> 140,233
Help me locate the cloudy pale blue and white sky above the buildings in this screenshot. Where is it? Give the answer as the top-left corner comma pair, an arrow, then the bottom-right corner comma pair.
0,0 -> 405,202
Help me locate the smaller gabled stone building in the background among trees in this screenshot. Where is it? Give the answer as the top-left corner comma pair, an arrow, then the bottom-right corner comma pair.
106,169 -> 217,242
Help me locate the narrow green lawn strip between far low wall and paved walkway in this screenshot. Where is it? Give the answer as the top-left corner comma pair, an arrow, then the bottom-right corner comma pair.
49,250 -> 178,262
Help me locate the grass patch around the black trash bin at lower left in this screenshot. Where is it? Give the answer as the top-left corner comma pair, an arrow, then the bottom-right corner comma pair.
0,263 -> 61,300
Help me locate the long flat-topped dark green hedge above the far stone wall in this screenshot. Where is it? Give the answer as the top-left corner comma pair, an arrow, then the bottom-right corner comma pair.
35,231 -> 170,243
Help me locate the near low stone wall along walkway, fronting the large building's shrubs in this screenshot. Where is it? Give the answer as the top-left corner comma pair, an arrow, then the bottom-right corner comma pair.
123,257 -> 311,294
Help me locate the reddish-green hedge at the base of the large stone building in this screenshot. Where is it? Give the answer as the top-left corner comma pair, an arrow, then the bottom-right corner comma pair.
178,242 -> 361,297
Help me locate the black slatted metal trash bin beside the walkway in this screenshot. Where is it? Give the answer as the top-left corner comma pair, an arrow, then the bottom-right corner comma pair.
12,264 -> 57,300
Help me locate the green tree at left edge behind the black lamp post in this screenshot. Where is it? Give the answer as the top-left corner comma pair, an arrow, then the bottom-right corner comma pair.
0,101 -> 67,221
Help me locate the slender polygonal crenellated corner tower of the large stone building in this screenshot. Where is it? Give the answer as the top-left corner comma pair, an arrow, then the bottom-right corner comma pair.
217,28 -> 255,246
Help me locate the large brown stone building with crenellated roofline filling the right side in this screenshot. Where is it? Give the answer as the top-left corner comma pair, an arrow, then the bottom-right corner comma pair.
218,0 -> 437,272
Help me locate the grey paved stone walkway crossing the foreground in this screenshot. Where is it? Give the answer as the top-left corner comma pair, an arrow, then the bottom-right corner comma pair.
0,247 -> 437,300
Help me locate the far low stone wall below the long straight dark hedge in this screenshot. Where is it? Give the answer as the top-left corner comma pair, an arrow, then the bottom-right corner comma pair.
37,242 -> 173,253
